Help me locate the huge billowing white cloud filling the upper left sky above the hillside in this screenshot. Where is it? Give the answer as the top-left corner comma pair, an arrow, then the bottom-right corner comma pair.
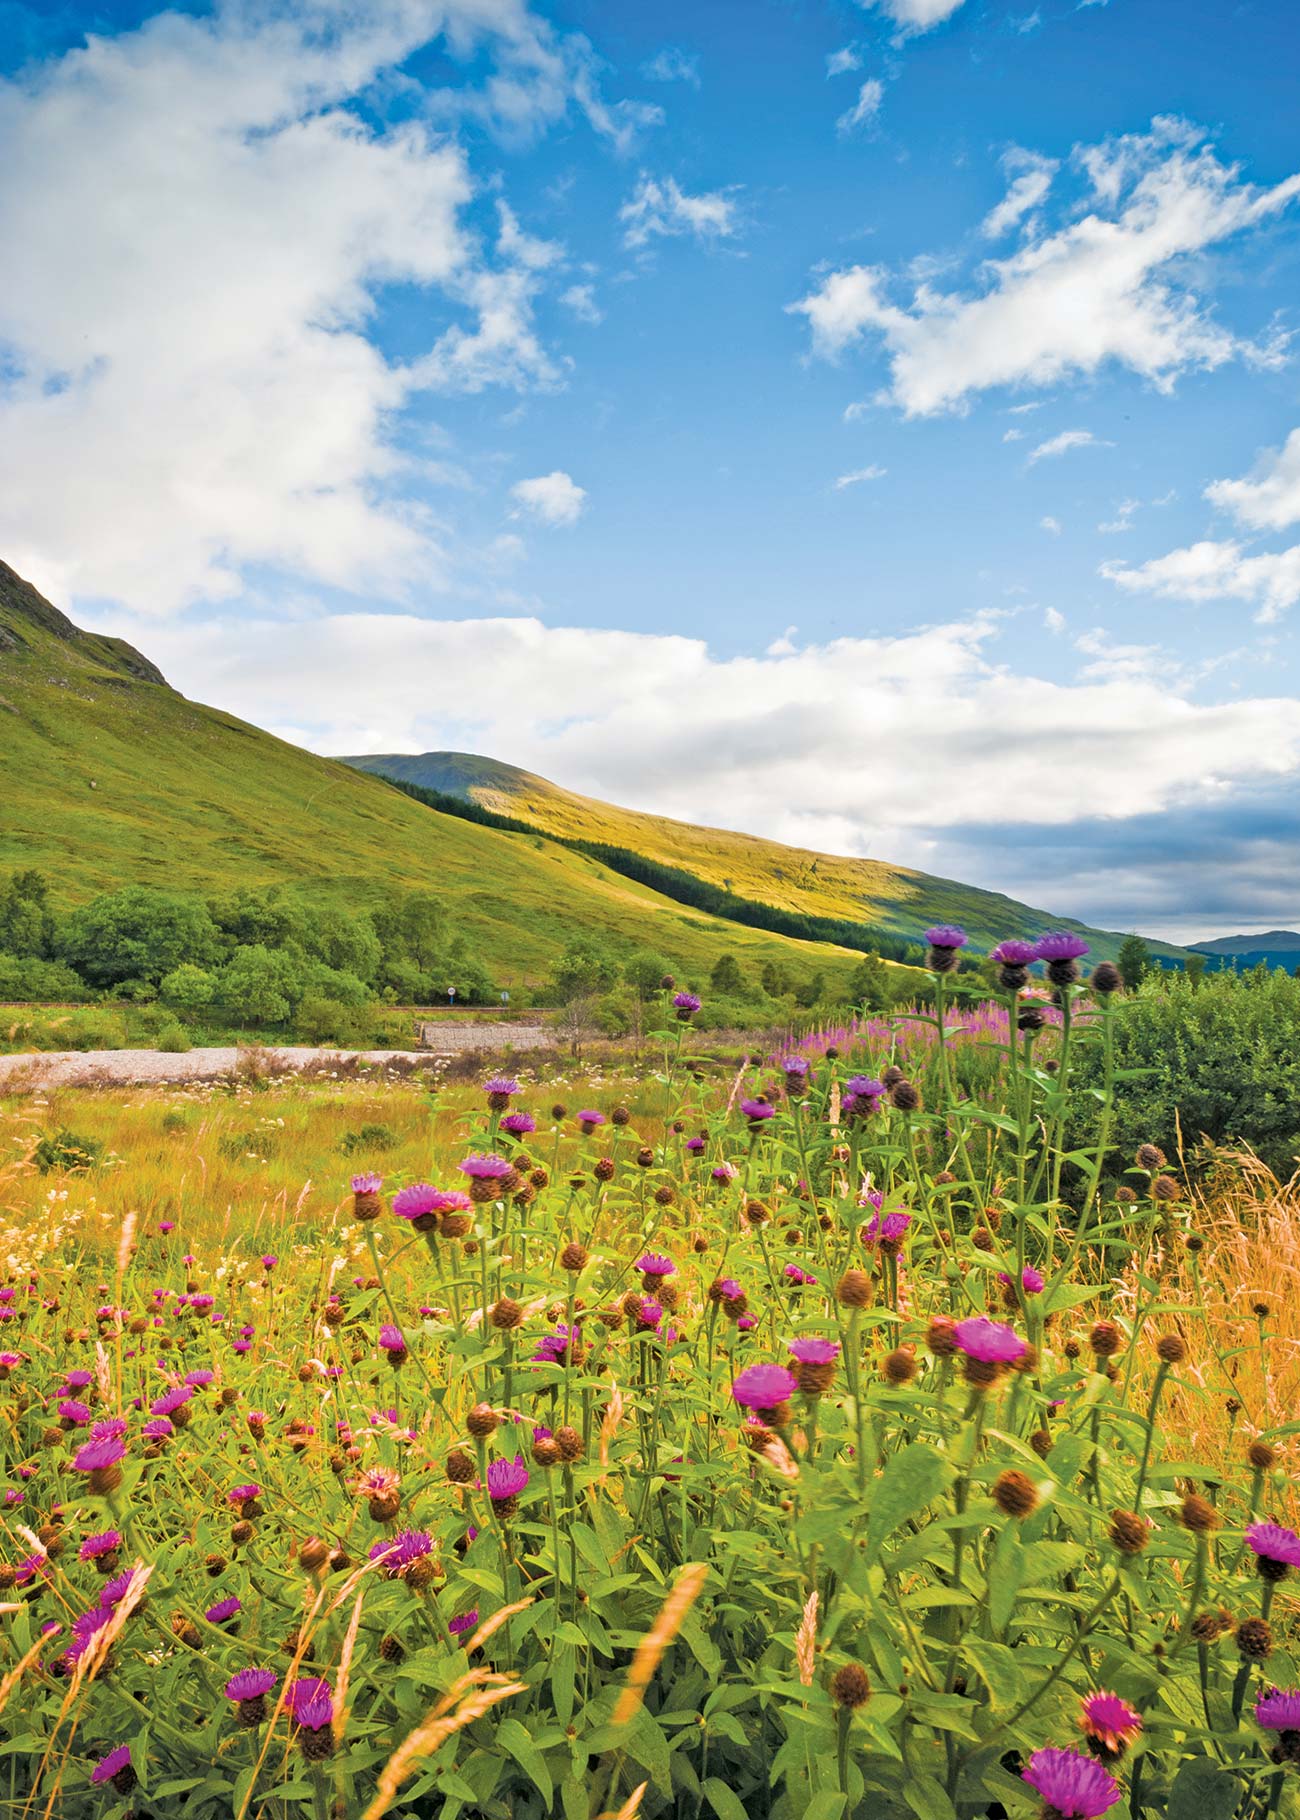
0,0 -> 623,612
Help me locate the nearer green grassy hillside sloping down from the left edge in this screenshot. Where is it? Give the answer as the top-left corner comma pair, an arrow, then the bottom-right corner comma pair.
0,562 -> 859,983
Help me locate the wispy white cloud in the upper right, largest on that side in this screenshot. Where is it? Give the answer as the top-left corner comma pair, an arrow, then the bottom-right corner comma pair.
788,120 -> 1300,417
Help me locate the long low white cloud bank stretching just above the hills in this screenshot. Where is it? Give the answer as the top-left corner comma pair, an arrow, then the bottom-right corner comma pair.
117,613 -> 1300,857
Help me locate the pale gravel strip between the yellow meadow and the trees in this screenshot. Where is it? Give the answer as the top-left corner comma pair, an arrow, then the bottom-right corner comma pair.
0,1023 -> 554,1088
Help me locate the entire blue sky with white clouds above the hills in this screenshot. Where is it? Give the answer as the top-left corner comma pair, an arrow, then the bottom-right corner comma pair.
0,0 -> 1300,937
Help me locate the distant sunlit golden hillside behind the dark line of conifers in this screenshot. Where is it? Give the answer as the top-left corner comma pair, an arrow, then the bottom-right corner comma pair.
346,752 -> 1182,957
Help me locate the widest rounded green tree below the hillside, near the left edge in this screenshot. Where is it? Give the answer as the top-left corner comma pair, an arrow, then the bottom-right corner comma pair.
60,885 -> 218,986
